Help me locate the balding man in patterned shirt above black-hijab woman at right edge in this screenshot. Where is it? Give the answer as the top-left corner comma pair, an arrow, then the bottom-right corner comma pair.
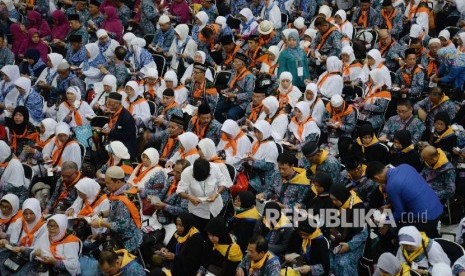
413,87 -> 457,129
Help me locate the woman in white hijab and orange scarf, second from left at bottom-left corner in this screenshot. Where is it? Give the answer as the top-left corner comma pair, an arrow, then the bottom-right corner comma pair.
0,198 -> 47,275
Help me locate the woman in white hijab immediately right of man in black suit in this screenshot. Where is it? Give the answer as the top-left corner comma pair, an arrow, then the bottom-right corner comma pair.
123,81 -> 152,127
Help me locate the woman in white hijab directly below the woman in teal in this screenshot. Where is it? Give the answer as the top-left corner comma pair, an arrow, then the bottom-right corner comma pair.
277,72 -> 302,112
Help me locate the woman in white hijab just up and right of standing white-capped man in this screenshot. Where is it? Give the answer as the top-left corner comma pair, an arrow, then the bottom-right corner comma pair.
128,148 -> 165,190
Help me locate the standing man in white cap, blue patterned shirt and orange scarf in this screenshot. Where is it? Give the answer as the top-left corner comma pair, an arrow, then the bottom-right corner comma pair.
90,166 -> 142,252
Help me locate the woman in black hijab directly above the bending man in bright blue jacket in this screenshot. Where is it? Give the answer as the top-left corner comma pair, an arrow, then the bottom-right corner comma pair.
388,130 -> 423,172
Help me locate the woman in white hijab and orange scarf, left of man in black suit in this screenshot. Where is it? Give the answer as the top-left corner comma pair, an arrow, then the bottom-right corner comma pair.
57,86 -> 95,127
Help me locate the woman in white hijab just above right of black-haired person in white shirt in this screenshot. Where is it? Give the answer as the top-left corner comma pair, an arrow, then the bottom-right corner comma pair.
217,119 -> 252,167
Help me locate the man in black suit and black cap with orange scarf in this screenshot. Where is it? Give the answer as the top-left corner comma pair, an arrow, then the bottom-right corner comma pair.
101,92 -> 137,161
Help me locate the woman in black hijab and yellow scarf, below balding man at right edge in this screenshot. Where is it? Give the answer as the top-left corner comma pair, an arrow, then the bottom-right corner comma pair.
419,111 -> 457,156
